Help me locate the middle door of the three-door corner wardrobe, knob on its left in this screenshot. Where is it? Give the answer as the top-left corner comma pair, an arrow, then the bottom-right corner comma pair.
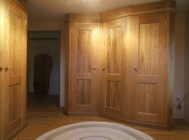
99,19 -> 126,117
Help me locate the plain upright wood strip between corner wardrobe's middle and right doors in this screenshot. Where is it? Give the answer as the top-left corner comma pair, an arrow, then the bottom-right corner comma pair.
125,16 -> 139,120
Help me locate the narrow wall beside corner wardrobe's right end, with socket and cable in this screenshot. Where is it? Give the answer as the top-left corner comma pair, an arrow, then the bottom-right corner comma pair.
173,13 -> 185,119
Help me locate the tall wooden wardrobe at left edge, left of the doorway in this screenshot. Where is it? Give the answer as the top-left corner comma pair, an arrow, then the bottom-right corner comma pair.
0,0 -> 28,139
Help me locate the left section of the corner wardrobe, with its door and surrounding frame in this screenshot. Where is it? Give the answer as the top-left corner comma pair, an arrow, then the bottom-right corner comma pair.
65,14 -> 99,115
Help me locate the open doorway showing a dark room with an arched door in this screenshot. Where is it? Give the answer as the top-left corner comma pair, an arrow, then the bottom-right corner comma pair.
28,31 -> 60,105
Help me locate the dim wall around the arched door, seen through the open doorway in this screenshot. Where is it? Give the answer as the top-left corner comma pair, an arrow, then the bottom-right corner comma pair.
28,32 -> 60,95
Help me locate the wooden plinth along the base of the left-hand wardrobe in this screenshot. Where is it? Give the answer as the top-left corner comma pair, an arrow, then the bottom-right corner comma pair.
4,122 -> 28,140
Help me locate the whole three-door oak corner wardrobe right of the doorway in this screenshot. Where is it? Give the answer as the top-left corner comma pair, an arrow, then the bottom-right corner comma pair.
65,0 -> 177,129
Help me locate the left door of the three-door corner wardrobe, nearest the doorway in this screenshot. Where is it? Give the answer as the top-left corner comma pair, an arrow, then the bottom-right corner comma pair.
70,22 -> 98,115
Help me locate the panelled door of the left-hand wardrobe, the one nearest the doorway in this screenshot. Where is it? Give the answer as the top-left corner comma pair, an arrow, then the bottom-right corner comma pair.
4,2 -> 27,139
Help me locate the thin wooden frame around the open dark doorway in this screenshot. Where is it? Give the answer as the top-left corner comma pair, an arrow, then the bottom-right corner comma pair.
27,30 -> 62,106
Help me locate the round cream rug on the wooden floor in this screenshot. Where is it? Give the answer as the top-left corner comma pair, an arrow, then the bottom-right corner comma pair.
36,122 -> 153,140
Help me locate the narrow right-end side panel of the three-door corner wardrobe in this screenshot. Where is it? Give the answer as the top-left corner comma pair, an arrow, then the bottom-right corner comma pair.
165,12 -> 175,125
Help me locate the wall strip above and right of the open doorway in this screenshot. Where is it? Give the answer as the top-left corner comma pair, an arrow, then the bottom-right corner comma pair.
28,22 -> 65,107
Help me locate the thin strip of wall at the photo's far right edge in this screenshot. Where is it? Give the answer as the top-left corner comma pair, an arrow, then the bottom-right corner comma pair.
184,11 -> 189,123
